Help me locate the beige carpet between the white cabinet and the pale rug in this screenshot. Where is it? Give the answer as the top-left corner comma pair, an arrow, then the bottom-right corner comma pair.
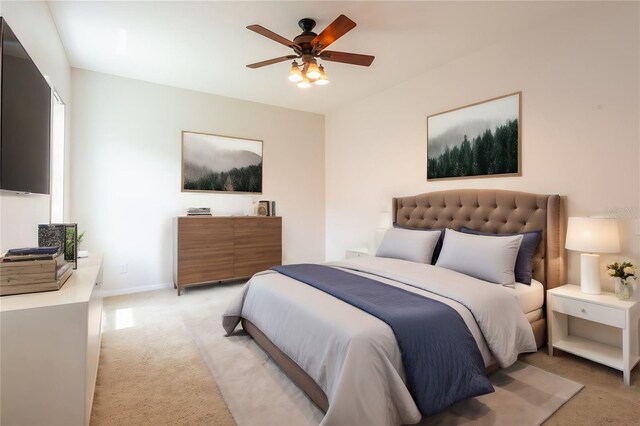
91,290 -> 235,426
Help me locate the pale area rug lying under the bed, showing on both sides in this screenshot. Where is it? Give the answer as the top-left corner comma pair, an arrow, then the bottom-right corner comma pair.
183,292 -> 583,426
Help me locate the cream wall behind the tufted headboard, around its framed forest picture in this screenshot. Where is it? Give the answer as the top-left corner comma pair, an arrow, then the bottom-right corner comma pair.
325,2 -> 640,292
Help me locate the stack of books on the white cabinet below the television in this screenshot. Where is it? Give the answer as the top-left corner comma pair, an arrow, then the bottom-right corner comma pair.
0,247 -> 73,296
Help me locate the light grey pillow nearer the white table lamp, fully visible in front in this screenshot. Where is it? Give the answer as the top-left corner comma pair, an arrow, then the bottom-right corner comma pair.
436,229 -> 522,285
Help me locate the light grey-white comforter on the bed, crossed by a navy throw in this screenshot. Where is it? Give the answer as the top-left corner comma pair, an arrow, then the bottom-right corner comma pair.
223,257 -> 536,425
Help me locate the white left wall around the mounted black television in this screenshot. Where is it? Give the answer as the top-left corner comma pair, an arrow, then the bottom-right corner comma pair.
0,0 -> 71,252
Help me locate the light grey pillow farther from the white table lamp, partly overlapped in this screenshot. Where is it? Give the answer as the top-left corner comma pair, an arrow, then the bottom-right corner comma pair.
376,228 -> 441,263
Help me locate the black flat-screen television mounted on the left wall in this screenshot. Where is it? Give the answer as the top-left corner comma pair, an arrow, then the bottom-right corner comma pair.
0,17 -> 51,194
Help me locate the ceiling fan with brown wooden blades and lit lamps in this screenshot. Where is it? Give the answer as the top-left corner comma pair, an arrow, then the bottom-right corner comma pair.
247,15 -> 375,88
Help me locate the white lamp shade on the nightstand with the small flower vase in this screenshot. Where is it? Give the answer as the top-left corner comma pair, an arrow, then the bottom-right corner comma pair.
565,217 -> 620,253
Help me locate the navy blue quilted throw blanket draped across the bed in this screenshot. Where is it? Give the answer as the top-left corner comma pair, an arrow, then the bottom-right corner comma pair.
271,264 -> 493,416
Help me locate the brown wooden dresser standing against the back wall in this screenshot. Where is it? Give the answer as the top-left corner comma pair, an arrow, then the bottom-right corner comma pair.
173,216 -> 282,295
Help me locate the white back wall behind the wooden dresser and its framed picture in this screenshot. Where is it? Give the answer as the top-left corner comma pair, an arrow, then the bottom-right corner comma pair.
72,69 -> 324,293
